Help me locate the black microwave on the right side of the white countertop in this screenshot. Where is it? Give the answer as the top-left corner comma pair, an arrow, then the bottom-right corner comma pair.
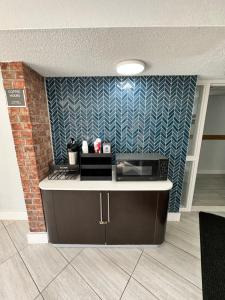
116,153 -> 169,181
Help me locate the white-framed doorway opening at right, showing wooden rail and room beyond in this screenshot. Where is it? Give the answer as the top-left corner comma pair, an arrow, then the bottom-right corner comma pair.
192,86 -> 225,211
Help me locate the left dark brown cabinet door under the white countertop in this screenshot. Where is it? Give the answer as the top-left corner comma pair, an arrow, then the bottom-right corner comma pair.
52,191 -> 105,244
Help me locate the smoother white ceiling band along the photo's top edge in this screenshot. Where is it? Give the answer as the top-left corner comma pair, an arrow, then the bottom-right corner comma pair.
0,0 -> 225,30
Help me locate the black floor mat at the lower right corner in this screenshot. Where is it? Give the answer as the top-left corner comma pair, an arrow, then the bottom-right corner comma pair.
199,212 -> 225,300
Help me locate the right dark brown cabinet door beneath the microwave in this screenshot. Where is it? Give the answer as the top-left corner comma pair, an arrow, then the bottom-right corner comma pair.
106,191 -> 158,245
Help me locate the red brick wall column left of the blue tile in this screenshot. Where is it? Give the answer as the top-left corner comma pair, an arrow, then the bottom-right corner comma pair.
1,62 -> 52,232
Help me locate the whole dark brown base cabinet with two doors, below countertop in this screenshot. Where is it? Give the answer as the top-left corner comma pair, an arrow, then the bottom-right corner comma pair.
42,190 -> 168,245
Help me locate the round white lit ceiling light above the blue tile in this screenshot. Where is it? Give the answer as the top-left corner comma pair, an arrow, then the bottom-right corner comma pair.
116,59 -> 145,76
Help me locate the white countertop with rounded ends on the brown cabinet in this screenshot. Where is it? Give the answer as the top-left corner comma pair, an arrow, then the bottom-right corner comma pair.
39,172 -> 173,191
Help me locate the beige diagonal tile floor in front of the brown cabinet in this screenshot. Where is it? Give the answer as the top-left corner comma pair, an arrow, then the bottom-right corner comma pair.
0,213 -> 214,300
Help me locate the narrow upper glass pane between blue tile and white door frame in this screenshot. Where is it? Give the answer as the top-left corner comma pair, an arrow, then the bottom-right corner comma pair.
188,85 -> 203,155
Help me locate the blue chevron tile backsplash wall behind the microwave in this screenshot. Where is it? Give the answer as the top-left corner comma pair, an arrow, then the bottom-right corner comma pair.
46,76 -> 197,212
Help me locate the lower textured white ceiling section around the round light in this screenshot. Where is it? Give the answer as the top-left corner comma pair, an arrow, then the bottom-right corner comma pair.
0,27 -> 225,78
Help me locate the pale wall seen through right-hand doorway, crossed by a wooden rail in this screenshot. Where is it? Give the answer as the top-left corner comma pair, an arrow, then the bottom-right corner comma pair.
198,96 -> 225,174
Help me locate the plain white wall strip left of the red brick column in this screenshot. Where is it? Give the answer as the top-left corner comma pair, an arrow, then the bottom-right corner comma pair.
0,70 -> 27,219
